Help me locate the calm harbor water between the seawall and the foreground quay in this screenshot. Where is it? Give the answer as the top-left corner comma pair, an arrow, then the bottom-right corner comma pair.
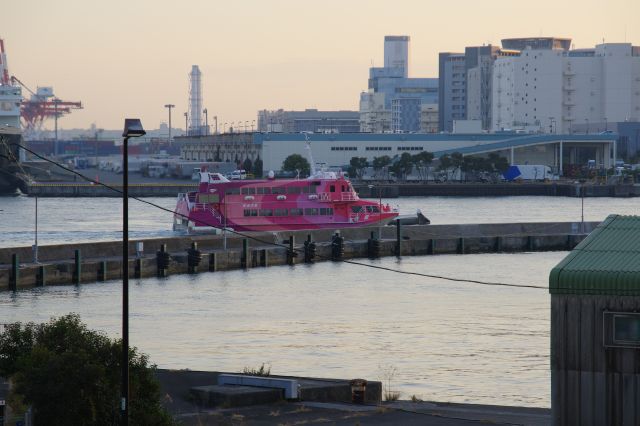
0,252 -> 566,407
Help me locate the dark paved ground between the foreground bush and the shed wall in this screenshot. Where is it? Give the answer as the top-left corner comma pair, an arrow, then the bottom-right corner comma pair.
158,370 -> 551,426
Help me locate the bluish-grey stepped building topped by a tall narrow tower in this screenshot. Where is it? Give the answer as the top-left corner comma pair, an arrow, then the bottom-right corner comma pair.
360,36 -> 438,133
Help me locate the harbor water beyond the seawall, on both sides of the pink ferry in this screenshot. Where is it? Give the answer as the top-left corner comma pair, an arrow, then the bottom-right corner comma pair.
0,196 -> 640,247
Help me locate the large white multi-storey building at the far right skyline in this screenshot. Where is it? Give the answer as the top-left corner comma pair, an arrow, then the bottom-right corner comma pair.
491,43 -> 640,133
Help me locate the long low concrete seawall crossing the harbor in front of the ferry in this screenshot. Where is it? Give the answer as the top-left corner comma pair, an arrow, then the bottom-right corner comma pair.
0,222 -> 598,290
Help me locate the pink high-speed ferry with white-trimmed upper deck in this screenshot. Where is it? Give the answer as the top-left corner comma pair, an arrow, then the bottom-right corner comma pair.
174,170 -> 398,232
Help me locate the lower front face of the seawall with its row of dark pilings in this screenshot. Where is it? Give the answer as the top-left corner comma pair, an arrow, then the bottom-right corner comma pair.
0,221 -> 586,290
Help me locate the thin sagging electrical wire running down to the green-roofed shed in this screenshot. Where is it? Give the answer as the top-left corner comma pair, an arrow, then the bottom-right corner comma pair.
11,143 -> 547,290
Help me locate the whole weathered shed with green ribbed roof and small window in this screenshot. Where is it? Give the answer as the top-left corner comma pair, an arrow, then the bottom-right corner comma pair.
549,215 -> 640,425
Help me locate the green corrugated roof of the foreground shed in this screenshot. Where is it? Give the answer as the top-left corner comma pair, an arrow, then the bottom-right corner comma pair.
549,215 -> 640,296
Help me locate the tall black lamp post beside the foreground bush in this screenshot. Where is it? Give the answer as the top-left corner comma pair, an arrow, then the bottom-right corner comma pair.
120,118 -> 146,426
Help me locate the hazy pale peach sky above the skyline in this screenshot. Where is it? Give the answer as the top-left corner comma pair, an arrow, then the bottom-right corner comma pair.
5,0 -> 640,129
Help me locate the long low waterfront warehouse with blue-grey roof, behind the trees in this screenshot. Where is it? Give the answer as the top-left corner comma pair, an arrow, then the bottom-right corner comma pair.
176,133 -> 617,175
